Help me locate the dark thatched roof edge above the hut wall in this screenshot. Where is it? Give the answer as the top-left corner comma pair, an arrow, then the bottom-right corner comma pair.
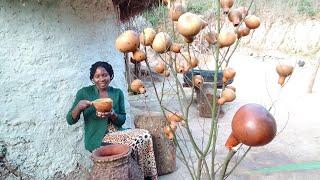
112,0 -> 161,21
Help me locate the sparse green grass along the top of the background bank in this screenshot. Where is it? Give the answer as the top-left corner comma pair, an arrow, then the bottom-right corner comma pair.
142,0 -> 320,28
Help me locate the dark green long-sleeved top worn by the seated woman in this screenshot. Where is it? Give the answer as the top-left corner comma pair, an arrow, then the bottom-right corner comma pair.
67,85 -> 126,152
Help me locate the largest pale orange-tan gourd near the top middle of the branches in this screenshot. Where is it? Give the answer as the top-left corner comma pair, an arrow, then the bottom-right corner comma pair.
177,12 -> 205,37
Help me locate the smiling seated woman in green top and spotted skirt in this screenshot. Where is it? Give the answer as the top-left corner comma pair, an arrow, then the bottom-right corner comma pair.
67,61 -> 157,179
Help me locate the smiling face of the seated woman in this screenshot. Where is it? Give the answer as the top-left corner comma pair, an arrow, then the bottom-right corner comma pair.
92,67 -> 111,89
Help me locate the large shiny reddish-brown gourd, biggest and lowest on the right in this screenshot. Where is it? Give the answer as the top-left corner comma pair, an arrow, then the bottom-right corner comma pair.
225,104 -> 277,149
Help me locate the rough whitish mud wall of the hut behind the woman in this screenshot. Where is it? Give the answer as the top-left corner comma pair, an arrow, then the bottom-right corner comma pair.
0,0 -> 131,179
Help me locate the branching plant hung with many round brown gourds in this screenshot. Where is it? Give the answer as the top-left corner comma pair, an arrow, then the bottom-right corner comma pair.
115,0 -> 292,179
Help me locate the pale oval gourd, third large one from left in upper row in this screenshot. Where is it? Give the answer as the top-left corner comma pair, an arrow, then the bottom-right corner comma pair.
152,32 -> 172,53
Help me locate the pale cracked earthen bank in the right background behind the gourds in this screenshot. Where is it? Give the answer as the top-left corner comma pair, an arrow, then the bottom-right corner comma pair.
241,15 -> 320,57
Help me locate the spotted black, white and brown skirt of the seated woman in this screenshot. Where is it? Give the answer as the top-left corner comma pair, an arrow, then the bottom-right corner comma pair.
103,124 -> 157,179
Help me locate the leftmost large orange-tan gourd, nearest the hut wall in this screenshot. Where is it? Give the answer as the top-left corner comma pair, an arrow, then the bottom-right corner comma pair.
116,30 -> 140,53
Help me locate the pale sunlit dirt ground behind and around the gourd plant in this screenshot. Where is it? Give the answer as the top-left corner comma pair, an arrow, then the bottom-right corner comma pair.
129,48 -> 320,180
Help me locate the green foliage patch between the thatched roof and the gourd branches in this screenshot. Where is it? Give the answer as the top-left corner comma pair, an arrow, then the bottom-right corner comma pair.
142,5 -> 168,27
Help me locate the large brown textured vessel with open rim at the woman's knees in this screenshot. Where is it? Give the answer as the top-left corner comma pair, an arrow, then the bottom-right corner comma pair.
91,144 -> 144,180
